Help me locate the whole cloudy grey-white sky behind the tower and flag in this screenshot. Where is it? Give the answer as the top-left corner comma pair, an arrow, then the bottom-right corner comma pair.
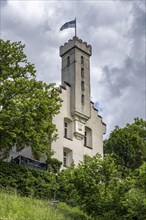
0,0 -> 146,137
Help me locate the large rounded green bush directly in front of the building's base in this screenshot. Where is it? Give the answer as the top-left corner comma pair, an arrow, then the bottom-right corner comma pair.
58,155 -> 128,220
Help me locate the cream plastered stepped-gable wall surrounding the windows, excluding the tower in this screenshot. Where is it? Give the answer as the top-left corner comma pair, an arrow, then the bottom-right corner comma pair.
52,86 -> 105,165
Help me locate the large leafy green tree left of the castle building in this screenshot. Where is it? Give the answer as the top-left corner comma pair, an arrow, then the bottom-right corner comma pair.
0,40 -> 61,156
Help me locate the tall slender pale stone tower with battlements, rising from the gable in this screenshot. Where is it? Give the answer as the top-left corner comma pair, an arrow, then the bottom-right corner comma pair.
60,36 -> 92,138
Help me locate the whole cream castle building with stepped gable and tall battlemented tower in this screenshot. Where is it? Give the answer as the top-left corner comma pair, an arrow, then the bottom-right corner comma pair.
52,36 -> 106,167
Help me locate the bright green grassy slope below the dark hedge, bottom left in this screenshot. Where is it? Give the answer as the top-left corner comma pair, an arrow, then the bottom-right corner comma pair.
0,190 -> 92,220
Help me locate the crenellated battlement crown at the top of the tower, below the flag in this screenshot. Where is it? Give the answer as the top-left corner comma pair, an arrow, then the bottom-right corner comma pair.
60,36 -> 92,57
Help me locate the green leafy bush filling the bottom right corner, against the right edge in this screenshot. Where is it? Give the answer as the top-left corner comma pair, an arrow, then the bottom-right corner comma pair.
121,162 -> 146,220
